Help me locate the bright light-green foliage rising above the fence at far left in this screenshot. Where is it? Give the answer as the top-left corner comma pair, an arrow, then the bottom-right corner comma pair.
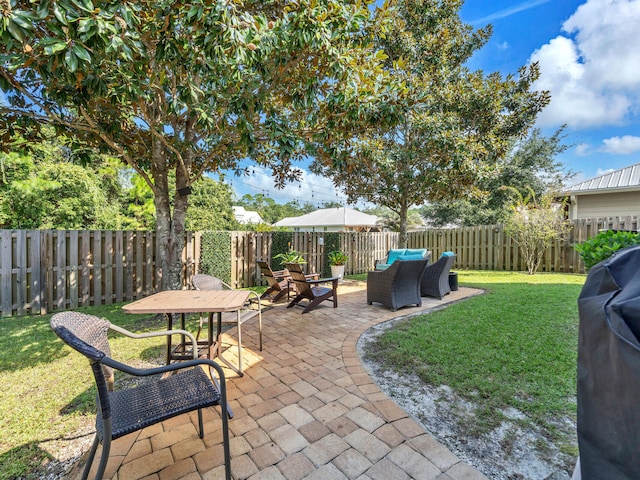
0,133 -> 123,229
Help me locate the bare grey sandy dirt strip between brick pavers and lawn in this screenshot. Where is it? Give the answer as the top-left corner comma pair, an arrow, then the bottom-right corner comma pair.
358,319 -> 577,480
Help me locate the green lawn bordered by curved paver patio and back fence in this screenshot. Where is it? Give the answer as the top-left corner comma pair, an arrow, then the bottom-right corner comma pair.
360,271 -> 586,454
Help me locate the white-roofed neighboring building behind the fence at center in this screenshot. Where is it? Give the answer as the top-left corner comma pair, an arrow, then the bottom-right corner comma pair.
273,207 -> 380,232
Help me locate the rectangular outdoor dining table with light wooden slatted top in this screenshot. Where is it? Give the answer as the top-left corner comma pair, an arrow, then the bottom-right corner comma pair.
122,290 -> 251,376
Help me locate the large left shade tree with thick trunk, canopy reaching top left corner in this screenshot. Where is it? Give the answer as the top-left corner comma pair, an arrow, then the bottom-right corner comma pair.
0,0 -> 397,289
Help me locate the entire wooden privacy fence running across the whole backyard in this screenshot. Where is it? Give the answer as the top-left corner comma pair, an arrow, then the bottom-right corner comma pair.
0,216 -> 638,316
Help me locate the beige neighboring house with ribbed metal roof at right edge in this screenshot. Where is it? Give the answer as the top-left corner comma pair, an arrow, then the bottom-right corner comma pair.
566,163 -> 640,220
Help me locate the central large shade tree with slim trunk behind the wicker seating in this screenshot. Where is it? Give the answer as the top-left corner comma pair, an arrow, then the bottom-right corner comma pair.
315,0 -> 548,246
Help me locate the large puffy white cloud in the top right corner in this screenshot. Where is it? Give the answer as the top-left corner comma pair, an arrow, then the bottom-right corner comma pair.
530,0 -> 640,128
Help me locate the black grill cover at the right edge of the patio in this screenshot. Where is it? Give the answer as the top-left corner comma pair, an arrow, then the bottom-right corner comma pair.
578,247 -> 640,480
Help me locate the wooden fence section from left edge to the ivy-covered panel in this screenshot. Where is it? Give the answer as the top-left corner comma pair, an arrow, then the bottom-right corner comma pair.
0,230 -> 200,316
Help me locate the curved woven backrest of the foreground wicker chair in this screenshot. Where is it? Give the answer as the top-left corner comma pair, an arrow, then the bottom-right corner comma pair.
50,312 -> 113,420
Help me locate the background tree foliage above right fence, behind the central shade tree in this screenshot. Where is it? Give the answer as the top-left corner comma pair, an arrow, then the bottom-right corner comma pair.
421,127 -> 573,226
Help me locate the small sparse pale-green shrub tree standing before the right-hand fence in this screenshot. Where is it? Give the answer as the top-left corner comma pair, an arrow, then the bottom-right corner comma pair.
505,188 -> 571,275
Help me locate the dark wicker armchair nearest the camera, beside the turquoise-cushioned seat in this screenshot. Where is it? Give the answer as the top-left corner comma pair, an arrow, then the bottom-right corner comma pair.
367,258 -> 429,312
